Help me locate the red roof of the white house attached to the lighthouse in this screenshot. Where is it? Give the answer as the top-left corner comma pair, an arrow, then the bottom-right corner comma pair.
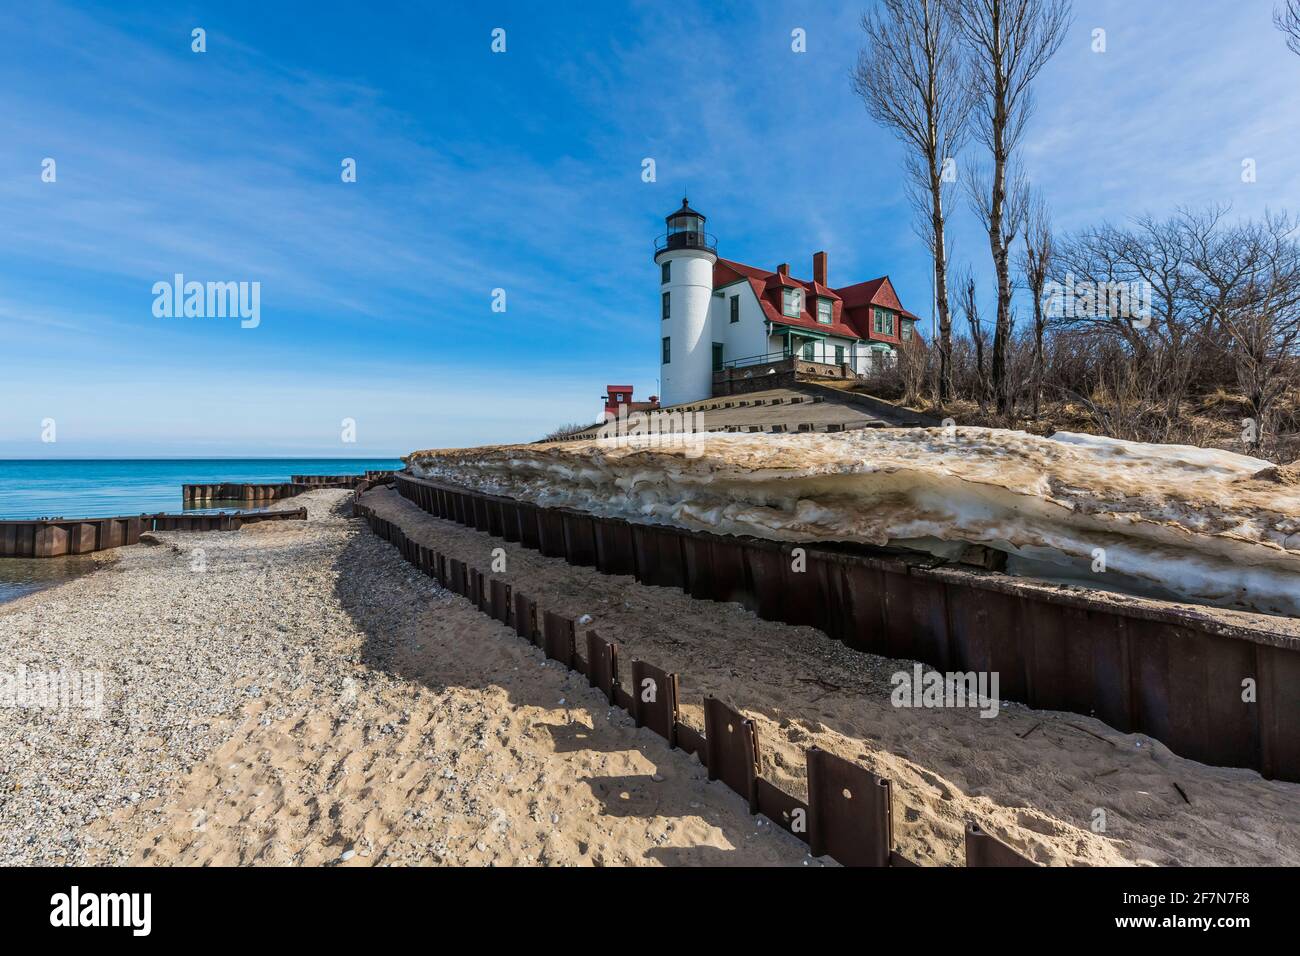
714,259 -> 917,342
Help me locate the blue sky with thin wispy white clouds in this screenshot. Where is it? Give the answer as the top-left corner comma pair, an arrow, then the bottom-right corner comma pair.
0,0 -> 1300,458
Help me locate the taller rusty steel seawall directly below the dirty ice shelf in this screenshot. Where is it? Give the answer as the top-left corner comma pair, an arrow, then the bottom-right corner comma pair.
395,475 -> 1300,782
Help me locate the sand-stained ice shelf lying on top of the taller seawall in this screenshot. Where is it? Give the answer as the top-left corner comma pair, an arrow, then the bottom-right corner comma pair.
408,428 -> 1300,617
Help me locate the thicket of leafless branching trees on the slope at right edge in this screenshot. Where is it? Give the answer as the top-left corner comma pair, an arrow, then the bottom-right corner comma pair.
1049,206 -> 1300,450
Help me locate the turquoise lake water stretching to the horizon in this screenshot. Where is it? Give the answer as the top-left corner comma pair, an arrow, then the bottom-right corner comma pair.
0,458 -> 402,520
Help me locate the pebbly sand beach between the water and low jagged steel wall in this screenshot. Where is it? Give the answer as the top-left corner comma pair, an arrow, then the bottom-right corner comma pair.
0,492 -> 820,866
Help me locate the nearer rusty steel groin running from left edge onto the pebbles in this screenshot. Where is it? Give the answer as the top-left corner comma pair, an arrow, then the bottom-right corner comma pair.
0,509 -> 307,558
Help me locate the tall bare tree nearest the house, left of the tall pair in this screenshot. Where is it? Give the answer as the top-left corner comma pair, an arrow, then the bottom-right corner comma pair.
853,0 -> 970,402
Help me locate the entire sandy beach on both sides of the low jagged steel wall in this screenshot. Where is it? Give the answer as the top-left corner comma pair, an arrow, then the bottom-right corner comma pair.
0,489 -> 1300,866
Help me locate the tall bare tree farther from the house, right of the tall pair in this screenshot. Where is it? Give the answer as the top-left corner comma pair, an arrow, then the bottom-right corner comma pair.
954,0 -> 1070,415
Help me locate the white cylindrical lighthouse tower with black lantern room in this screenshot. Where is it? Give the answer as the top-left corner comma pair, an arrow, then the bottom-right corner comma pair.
654,199 -> 718,406
